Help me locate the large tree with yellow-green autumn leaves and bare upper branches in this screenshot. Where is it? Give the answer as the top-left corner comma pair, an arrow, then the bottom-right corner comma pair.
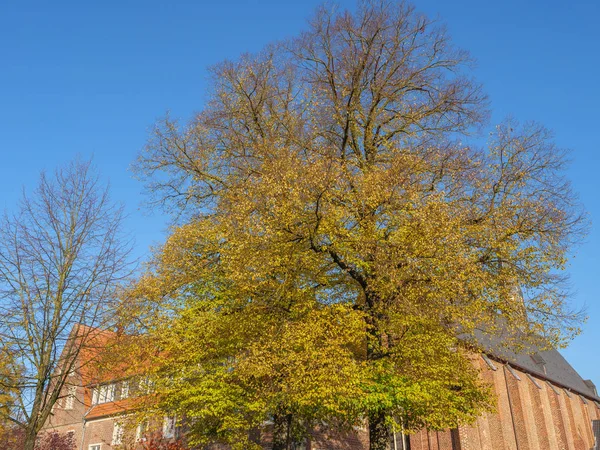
135,0 -> 585,450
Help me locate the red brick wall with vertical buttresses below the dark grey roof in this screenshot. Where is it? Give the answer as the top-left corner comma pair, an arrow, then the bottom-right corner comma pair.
411,360 -> 600,450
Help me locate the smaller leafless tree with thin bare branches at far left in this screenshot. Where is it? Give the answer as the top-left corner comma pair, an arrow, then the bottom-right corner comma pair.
0,161 -> 129,450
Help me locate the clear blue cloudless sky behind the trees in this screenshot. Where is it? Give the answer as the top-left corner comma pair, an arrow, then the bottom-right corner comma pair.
0,0 -> 600,385
